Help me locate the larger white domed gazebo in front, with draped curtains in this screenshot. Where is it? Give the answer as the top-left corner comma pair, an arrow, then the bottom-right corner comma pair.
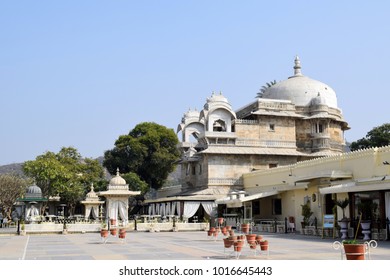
98,169 -> 141,226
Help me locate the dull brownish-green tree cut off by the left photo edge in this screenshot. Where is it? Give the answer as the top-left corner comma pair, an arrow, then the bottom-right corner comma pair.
0,174 -> 28,219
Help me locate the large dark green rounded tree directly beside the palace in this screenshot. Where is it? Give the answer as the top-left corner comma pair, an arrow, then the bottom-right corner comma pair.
103,122 -> 180,189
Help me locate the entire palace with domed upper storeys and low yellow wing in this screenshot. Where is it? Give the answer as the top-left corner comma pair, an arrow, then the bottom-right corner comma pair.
145,57 -> 390,241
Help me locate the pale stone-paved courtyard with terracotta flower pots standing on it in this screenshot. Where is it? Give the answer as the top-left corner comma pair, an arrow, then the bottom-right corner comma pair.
0,231 -> 390,260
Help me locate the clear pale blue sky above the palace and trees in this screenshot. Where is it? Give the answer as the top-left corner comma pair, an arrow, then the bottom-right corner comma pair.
0,0 -> 390,165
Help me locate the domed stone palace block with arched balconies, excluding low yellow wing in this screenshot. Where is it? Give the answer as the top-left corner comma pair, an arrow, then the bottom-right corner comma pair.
177,57 -> 349,198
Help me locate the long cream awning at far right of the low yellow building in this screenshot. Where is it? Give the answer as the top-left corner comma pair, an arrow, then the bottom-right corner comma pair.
320,182 -> 390,194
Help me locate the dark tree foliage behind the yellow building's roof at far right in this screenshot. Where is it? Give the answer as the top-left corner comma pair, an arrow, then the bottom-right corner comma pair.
350,123 -> 390,151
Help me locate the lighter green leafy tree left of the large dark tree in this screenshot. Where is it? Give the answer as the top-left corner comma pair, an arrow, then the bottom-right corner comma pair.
23,147 -> 104,213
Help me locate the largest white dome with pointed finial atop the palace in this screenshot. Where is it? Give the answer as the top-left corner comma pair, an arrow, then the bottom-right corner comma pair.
262,57 -> 337,108
